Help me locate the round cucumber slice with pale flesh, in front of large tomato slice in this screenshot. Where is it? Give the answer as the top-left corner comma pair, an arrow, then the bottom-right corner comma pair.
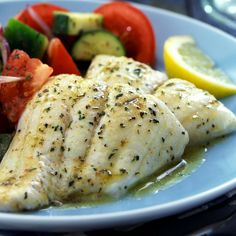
72,30 -> 125,60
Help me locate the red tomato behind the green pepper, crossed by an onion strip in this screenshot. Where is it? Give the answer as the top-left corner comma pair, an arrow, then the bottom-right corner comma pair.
16,3 -> 68,33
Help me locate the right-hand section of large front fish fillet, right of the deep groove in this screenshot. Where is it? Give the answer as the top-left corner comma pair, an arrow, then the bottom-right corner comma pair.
71,84 -> 189,199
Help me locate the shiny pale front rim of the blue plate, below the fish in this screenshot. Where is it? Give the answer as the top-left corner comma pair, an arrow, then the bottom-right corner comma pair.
0,178 -> 236,232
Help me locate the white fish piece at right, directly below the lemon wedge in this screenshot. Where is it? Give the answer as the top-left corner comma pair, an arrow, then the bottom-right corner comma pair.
154,79 -> 236,145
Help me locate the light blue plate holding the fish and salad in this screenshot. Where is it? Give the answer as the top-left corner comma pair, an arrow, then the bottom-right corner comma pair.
0,0 -> 236,232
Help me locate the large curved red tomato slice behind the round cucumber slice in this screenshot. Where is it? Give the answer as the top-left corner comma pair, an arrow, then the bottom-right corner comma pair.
95,2 -> 156,65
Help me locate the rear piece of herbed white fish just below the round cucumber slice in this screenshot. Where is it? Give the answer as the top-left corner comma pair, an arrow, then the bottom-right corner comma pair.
86,55 -> 167,93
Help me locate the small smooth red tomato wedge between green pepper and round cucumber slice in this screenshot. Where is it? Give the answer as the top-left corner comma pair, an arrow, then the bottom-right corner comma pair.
48,38 -> 80,75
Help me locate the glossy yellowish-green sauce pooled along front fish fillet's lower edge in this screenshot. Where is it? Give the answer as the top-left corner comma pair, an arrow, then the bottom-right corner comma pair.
54,147 -> 207,208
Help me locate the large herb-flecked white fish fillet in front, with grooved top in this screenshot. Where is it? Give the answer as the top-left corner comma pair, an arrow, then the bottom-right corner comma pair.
0,75 -> 189,211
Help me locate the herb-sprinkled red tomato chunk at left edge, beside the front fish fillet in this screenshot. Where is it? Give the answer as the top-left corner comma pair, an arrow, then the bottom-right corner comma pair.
0,49 -> 53,123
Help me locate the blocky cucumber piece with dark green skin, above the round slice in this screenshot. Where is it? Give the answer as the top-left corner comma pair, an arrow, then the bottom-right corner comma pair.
53,11 -> 103,35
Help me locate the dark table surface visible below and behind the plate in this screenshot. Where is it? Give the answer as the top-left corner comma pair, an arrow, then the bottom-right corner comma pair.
0,0 -> 236,236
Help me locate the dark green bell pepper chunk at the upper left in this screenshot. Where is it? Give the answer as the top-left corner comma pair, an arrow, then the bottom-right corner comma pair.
4,18 -> 48,59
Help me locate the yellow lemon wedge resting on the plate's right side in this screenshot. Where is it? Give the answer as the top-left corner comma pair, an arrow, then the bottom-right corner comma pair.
164,35 -> 236,98
